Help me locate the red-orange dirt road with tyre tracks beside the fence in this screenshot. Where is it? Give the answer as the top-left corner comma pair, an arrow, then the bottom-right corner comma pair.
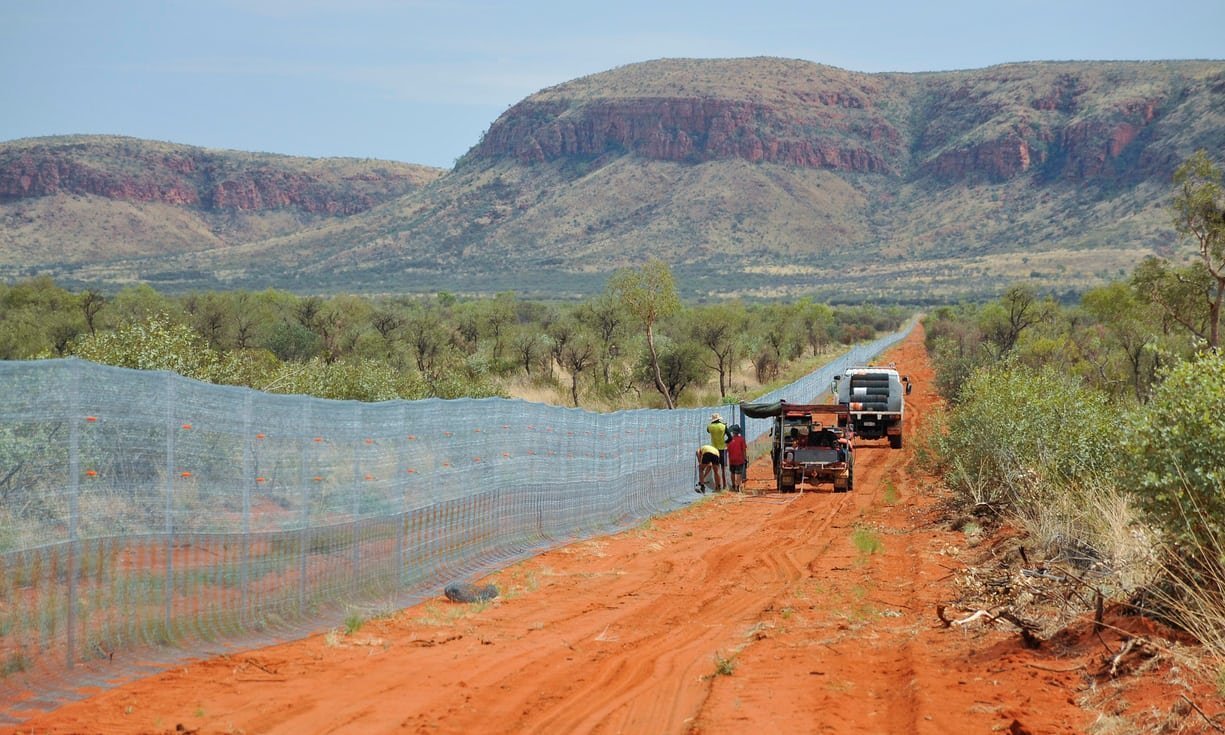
9,331 -> 1215,735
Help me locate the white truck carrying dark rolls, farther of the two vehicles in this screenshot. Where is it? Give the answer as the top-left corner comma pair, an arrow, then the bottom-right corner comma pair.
833,364 -> 910,450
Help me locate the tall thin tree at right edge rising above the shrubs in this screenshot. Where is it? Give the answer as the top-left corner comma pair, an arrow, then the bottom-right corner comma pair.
1174,149 -> 1225,350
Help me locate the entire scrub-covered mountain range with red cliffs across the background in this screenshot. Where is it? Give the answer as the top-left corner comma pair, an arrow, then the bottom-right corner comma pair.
0,58 -> 1225,303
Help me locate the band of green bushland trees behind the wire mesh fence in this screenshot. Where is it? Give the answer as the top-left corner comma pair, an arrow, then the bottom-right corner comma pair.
0,261 -> 908,410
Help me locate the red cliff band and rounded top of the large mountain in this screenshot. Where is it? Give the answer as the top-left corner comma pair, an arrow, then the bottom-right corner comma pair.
464,59 -> 1221,183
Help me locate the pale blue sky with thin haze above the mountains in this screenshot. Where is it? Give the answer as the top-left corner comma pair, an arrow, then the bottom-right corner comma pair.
0,0 -> 1225,167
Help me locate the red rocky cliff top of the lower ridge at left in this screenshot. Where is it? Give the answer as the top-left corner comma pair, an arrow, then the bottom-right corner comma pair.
0,137 -> 441,216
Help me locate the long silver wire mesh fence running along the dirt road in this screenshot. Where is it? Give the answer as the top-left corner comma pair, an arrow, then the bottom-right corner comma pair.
0,328 -> 909,724
